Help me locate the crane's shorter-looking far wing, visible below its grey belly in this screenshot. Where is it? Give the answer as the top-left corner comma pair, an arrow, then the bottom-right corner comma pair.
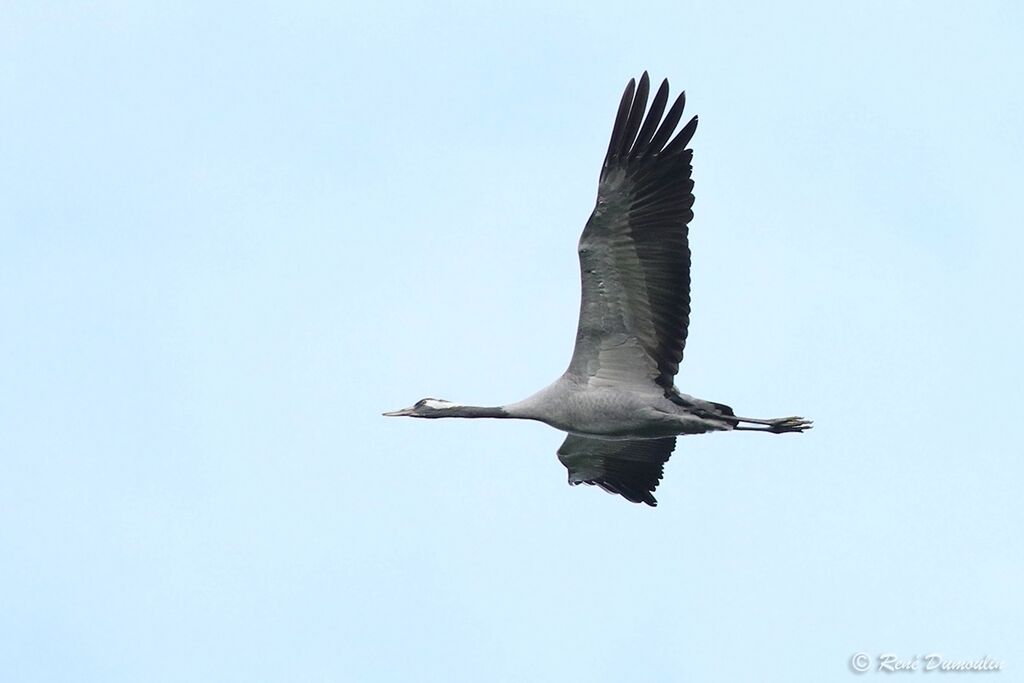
558,434 -> 676,507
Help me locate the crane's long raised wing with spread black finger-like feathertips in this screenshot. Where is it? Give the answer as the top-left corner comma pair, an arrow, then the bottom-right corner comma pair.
568,73 -> 697,390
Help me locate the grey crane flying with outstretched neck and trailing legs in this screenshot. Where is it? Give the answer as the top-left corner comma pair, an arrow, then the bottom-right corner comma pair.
384,72 -> 811,506
